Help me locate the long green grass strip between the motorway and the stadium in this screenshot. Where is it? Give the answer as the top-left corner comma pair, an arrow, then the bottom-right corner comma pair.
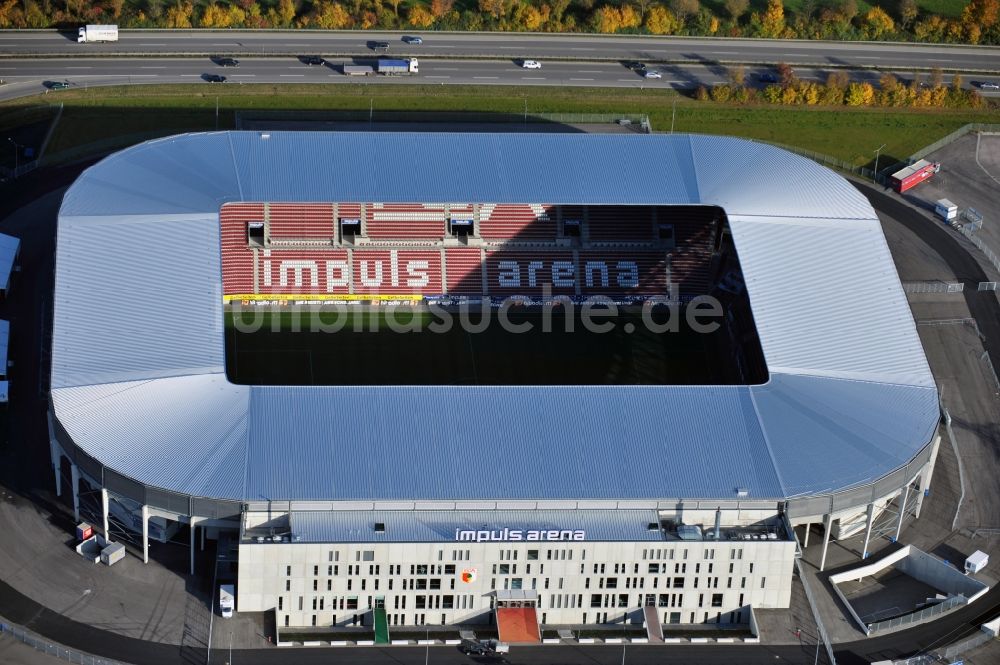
0,83 -> 996,169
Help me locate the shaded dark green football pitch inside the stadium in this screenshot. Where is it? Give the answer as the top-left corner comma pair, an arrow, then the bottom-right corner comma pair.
226,307 -> 763,386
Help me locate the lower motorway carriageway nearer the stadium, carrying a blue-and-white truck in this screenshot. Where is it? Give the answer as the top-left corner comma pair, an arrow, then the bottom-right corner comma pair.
0,56 -> 1000,99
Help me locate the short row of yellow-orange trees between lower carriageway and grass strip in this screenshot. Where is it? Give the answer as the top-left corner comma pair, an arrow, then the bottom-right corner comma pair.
695,64 -> 985,108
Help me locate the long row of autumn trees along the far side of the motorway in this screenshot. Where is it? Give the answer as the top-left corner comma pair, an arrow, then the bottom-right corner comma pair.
0,0 -> 1000,44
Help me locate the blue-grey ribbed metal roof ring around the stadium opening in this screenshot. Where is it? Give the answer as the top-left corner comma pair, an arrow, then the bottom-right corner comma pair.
52,132 -> 938,501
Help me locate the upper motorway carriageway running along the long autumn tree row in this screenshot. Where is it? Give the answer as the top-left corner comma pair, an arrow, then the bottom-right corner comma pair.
0,30 -> 1000,73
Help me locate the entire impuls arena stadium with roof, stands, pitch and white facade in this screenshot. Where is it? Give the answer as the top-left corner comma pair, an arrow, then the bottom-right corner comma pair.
50,132 -> 939,642
